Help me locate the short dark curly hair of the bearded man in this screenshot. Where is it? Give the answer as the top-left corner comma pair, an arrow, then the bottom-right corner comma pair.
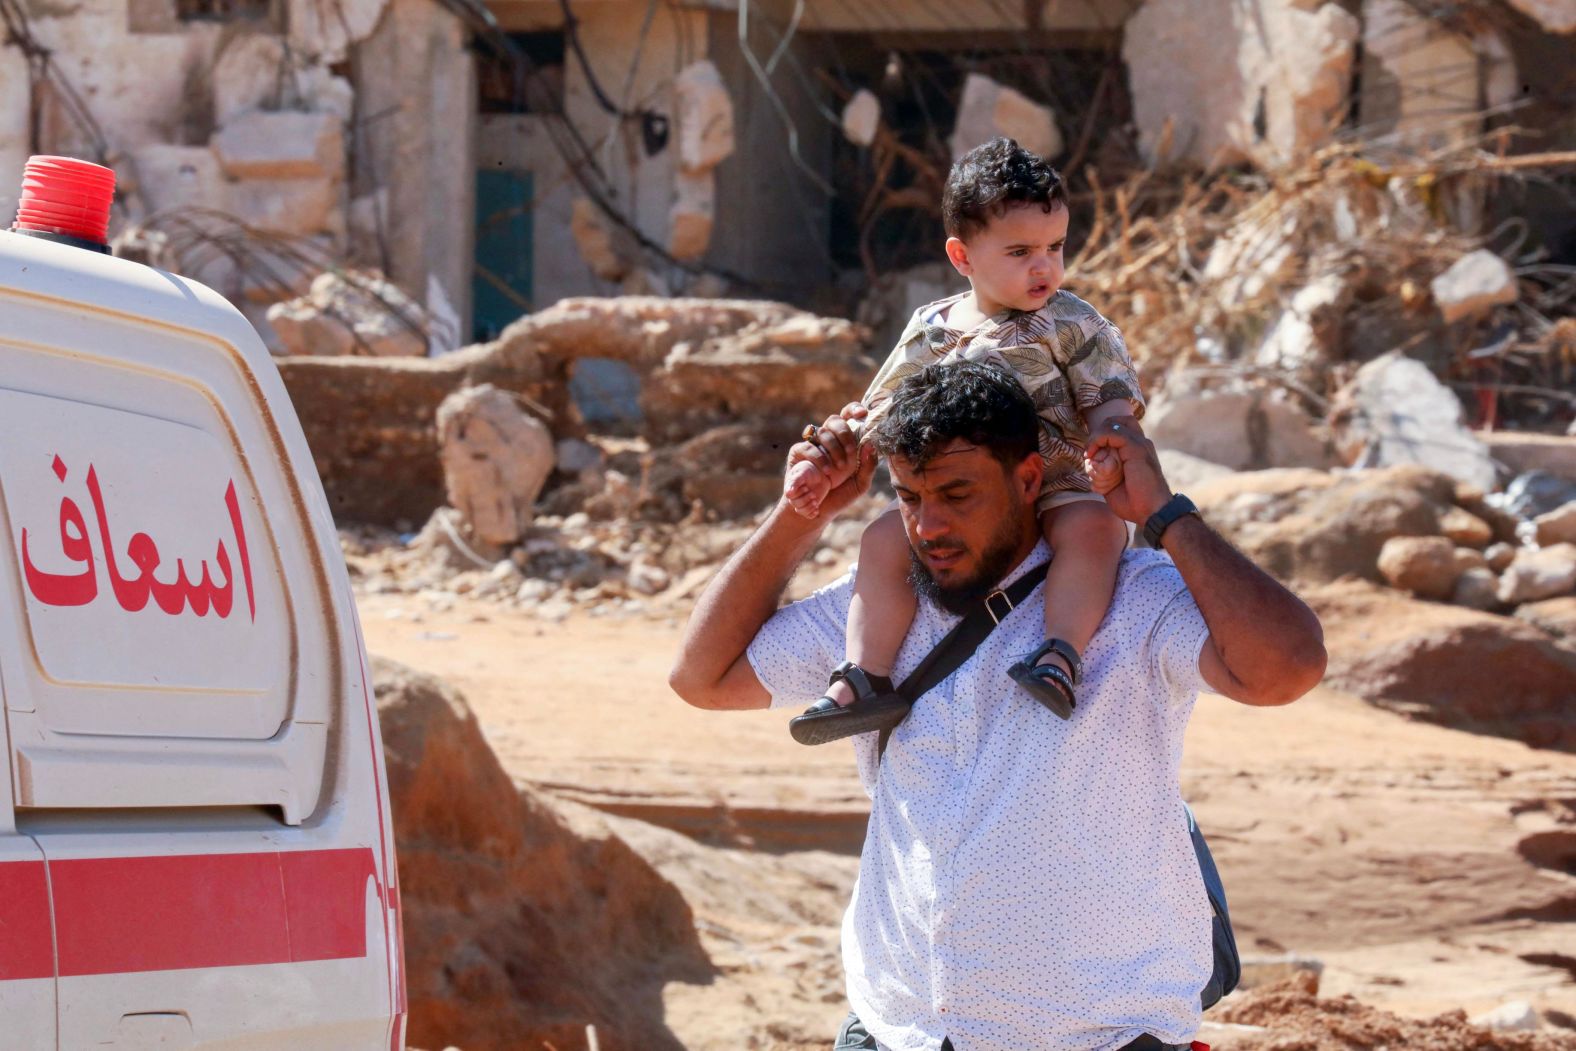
870,361 -> 1040,470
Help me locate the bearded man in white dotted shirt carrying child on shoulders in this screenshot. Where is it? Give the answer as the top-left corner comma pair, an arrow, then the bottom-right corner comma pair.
668,362 -> 1325,1051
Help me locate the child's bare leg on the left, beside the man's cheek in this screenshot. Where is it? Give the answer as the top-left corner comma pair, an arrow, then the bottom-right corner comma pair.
826,509 -> 919,704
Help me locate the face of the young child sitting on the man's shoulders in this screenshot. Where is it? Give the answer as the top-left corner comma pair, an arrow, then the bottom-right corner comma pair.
947,202 -> 1070,314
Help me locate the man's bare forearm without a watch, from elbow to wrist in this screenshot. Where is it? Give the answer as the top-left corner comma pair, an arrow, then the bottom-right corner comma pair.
668,501 -> 826,707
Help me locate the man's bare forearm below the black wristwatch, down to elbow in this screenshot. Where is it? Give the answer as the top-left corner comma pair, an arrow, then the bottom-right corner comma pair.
1162,515 -> 1325,704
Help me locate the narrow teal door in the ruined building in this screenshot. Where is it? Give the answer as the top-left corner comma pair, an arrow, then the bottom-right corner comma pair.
471,169 -> 531,342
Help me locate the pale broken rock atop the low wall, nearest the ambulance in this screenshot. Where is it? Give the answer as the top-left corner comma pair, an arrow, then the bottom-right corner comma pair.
268,271 -> 427,358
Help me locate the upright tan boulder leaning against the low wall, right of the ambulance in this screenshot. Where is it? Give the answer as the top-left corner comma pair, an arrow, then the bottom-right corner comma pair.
437,383 -> 553,547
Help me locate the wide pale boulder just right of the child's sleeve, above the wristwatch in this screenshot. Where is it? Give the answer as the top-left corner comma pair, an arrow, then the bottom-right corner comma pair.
1144,377 -> 1336,471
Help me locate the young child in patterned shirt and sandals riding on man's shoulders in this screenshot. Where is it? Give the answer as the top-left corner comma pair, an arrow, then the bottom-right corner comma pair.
785,139 -> 1144,744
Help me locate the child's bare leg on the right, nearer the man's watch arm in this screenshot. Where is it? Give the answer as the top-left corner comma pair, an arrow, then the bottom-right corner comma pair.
1040,500 -> 1127,683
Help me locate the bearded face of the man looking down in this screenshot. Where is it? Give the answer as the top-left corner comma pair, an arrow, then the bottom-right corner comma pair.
889,440 -> 1042,613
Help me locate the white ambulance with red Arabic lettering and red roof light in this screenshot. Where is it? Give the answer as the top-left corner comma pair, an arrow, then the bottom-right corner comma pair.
0,158 -> 405,1051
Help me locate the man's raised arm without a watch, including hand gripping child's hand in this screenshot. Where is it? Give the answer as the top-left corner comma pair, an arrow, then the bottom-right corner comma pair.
668,407 -> 876,709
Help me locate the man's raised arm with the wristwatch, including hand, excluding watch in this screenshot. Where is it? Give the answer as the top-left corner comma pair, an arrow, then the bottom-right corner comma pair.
1089,416 -> 1327,704
